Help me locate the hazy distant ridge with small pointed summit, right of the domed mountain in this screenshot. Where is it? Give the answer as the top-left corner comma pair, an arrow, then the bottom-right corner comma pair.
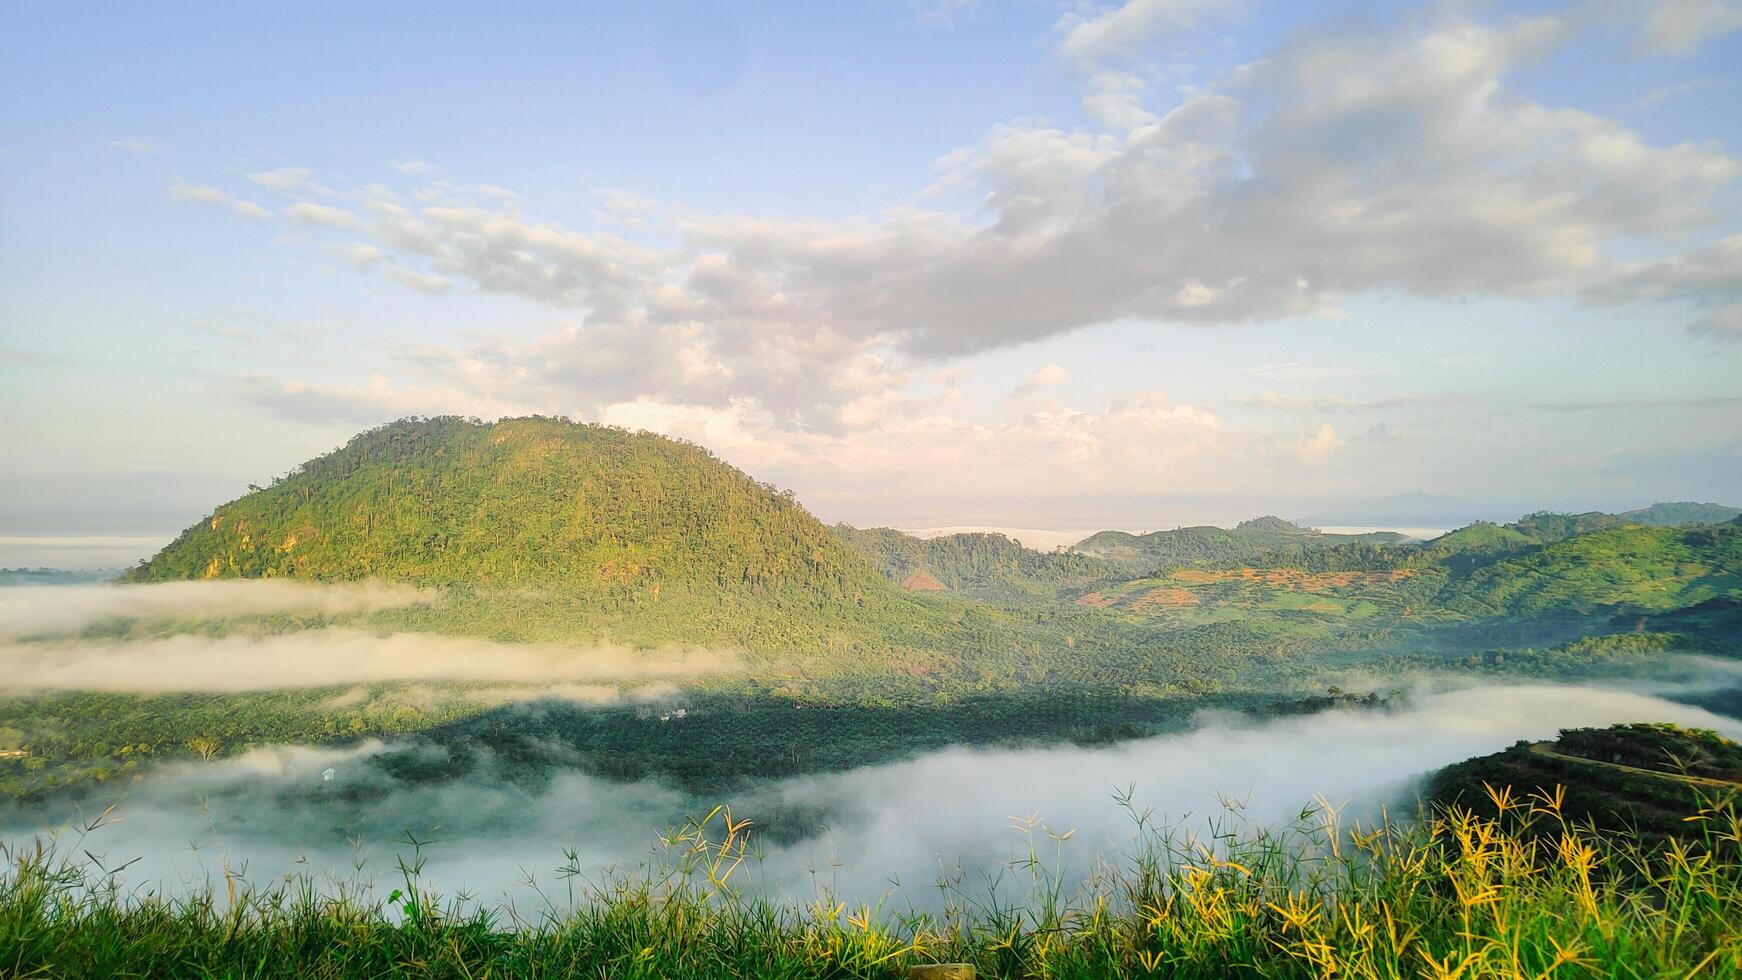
1071,517 -> 1408,574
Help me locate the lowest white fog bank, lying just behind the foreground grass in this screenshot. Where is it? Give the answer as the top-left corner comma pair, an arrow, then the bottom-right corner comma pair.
3,672 -> 1742,909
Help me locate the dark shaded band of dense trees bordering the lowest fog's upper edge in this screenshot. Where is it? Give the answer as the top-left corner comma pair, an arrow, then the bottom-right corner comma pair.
346,684 -> 1385,794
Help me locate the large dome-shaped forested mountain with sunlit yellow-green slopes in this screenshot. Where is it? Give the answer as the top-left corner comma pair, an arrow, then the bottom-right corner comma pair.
129,418 -> 961,649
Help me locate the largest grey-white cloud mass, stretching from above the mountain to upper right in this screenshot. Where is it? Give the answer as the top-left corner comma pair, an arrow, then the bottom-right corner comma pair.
166,0 -> 1742,480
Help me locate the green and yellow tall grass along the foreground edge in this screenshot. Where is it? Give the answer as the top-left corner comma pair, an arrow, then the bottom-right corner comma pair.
0,792 -> 1742,978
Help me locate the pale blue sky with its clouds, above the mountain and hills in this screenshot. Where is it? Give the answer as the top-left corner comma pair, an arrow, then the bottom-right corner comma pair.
0,0 -> 1742,540
